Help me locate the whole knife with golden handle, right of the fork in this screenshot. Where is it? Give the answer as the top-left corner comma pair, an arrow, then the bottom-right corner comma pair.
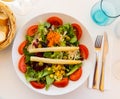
99,32 -> 109,91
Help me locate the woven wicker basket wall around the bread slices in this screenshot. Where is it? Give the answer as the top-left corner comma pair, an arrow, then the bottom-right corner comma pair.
0,2 -> 16,50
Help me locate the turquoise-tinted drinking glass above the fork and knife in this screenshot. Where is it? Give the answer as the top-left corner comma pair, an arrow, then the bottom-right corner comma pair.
90,0 -> 120,26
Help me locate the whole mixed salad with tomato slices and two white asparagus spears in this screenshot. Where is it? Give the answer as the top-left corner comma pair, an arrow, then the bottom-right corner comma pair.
18,16 -> 89,90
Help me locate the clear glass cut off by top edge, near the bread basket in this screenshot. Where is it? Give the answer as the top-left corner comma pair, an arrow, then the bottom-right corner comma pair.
1,0 -> 33,15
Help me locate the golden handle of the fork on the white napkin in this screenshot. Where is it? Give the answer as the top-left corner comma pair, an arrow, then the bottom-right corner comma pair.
93,55 -> 98,89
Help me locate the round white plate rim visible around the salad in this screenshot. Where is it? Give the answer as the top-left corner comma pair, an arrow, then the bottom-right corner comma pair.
12,13 -> 95,95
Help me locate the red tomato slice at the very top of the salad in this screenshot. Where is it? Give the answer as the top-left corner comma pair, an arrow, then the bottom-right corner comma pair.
47,16 -> 63,26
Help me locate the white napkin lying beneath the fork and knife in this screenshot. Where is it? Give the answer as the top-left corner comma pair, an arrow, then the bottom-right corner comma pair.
88,35 -> 112,90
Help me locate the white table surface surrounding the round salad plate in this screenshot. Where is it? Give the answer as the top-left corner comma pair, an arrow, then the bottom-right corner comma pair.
0,0 -> 120,99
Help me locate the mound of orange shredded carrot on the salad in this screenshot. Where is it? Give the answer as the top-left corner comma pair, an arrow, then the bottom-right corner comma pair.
47,31 -> 60,47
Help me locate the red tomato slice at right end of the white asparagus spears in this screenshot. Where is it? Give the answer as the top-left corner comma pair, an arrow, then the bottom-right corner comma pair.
79,44 -> 89,59
